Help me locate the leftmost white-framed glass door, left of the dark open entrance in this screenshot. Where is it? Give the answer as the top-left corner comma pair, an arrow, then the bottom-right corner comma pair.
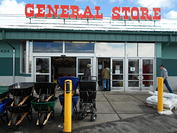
34,57 -> 51,82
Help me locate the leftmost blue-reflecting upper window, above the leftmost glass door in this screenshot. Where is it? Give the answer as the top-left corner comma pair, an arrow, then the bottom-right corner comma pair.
33,41 -> 63,53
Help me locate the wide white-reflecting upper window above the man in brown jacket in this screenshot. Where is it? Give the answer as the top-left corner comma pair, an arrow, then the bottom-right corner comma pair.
96,43 -> 125,57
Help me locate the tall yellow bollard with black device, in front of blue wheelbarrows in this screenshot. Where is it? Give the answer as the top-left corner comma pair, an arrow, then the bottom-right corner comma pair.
63,80 -> 72,133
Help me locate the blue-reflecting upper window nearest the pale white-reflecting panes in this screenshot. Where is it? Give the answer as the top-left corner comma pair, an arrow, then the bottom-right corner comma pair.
65,42 -> 94,53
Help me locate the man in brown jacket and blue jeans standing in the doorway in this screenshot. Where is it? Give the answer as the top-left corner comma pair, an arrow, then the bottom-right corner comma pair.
102,67 -> 110,91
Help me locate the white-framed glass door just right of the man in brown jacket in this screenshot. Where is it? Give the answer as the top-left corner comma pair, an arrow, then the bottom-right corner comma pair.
111,59 -> 124,90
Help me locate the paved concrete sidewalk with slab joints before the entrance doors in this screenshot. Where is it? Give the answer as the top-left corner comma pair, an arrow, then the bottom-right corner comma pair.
73,91 -> 156,129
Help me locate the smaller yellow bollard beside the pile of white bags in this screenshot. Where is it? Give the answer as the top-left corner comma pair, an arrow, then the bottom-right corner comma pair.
157,77 -> 164,113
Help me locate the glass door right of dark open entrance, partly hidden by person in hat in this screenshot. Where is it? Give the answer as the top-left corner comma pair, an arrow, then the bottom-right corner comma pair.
77,58 -> 93,79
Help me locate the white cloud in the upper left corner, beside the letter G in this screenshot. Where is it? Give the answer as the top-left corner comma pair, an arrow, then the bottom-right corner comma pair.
0,0 -> 25,14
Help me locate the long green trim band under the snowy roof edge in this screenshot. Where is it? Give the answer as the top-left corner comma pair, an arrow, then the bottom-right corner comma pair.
0,28 -> 177,42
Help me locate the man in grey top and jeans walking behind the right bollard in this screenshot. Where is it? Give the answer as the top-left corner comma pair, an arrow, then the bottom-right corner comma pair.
160,65 -> 173,93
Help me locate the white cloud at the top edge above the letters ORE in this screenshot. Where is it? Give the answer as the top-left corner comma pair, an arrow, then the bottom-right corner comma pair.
137,0 -> 176,8
